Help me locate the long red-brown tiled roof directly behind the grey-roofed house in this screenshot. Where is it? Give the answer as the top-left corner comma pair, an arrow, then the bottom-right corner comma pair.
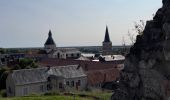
39,59 -> 122,71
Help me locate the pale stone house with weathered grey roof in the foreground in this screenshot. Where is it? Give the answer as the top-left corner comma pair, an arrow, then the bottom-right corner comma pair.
6,65 -> 87,96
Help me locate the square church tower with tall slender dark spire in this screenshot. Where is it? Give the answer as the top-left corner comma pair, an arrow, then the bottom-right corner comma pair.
102,26 -> 112,55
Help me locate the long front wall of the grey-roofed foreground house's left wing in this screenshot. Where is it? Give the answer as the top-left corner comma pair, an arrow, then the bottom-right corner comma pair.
15,82 -> 47,96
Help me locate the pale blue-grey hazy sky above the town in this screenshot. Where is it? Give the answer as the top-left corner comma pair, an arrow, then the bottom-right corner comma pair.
0,0 -> 162,48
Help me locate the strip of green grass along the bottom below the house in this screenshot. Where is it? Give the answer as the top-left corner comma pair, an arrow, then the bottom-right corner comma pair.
0,91 -> 112,100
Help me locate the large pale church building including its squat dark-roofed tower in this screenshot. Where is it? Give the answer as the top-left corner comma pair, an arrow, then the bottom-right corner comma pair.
26,30 -> 81,60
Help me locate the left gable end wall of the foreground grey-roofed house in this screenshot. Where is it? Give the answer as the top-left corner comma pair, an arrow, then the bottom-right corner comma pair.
6,74 -> 15,97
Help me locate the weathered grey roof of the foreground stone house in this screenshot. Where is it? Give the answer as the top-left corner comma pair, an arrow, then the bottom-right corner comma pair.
12,65 -> 86,85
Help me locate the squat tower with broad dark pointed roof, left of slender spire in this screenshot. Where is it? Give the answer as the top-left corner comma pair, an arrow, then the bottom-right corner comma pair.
44,30 -> 56,49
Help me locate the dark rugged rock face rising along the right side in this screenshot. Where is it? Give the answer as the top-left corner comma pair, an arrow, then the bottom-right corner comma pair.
111,0 -> 170,100
